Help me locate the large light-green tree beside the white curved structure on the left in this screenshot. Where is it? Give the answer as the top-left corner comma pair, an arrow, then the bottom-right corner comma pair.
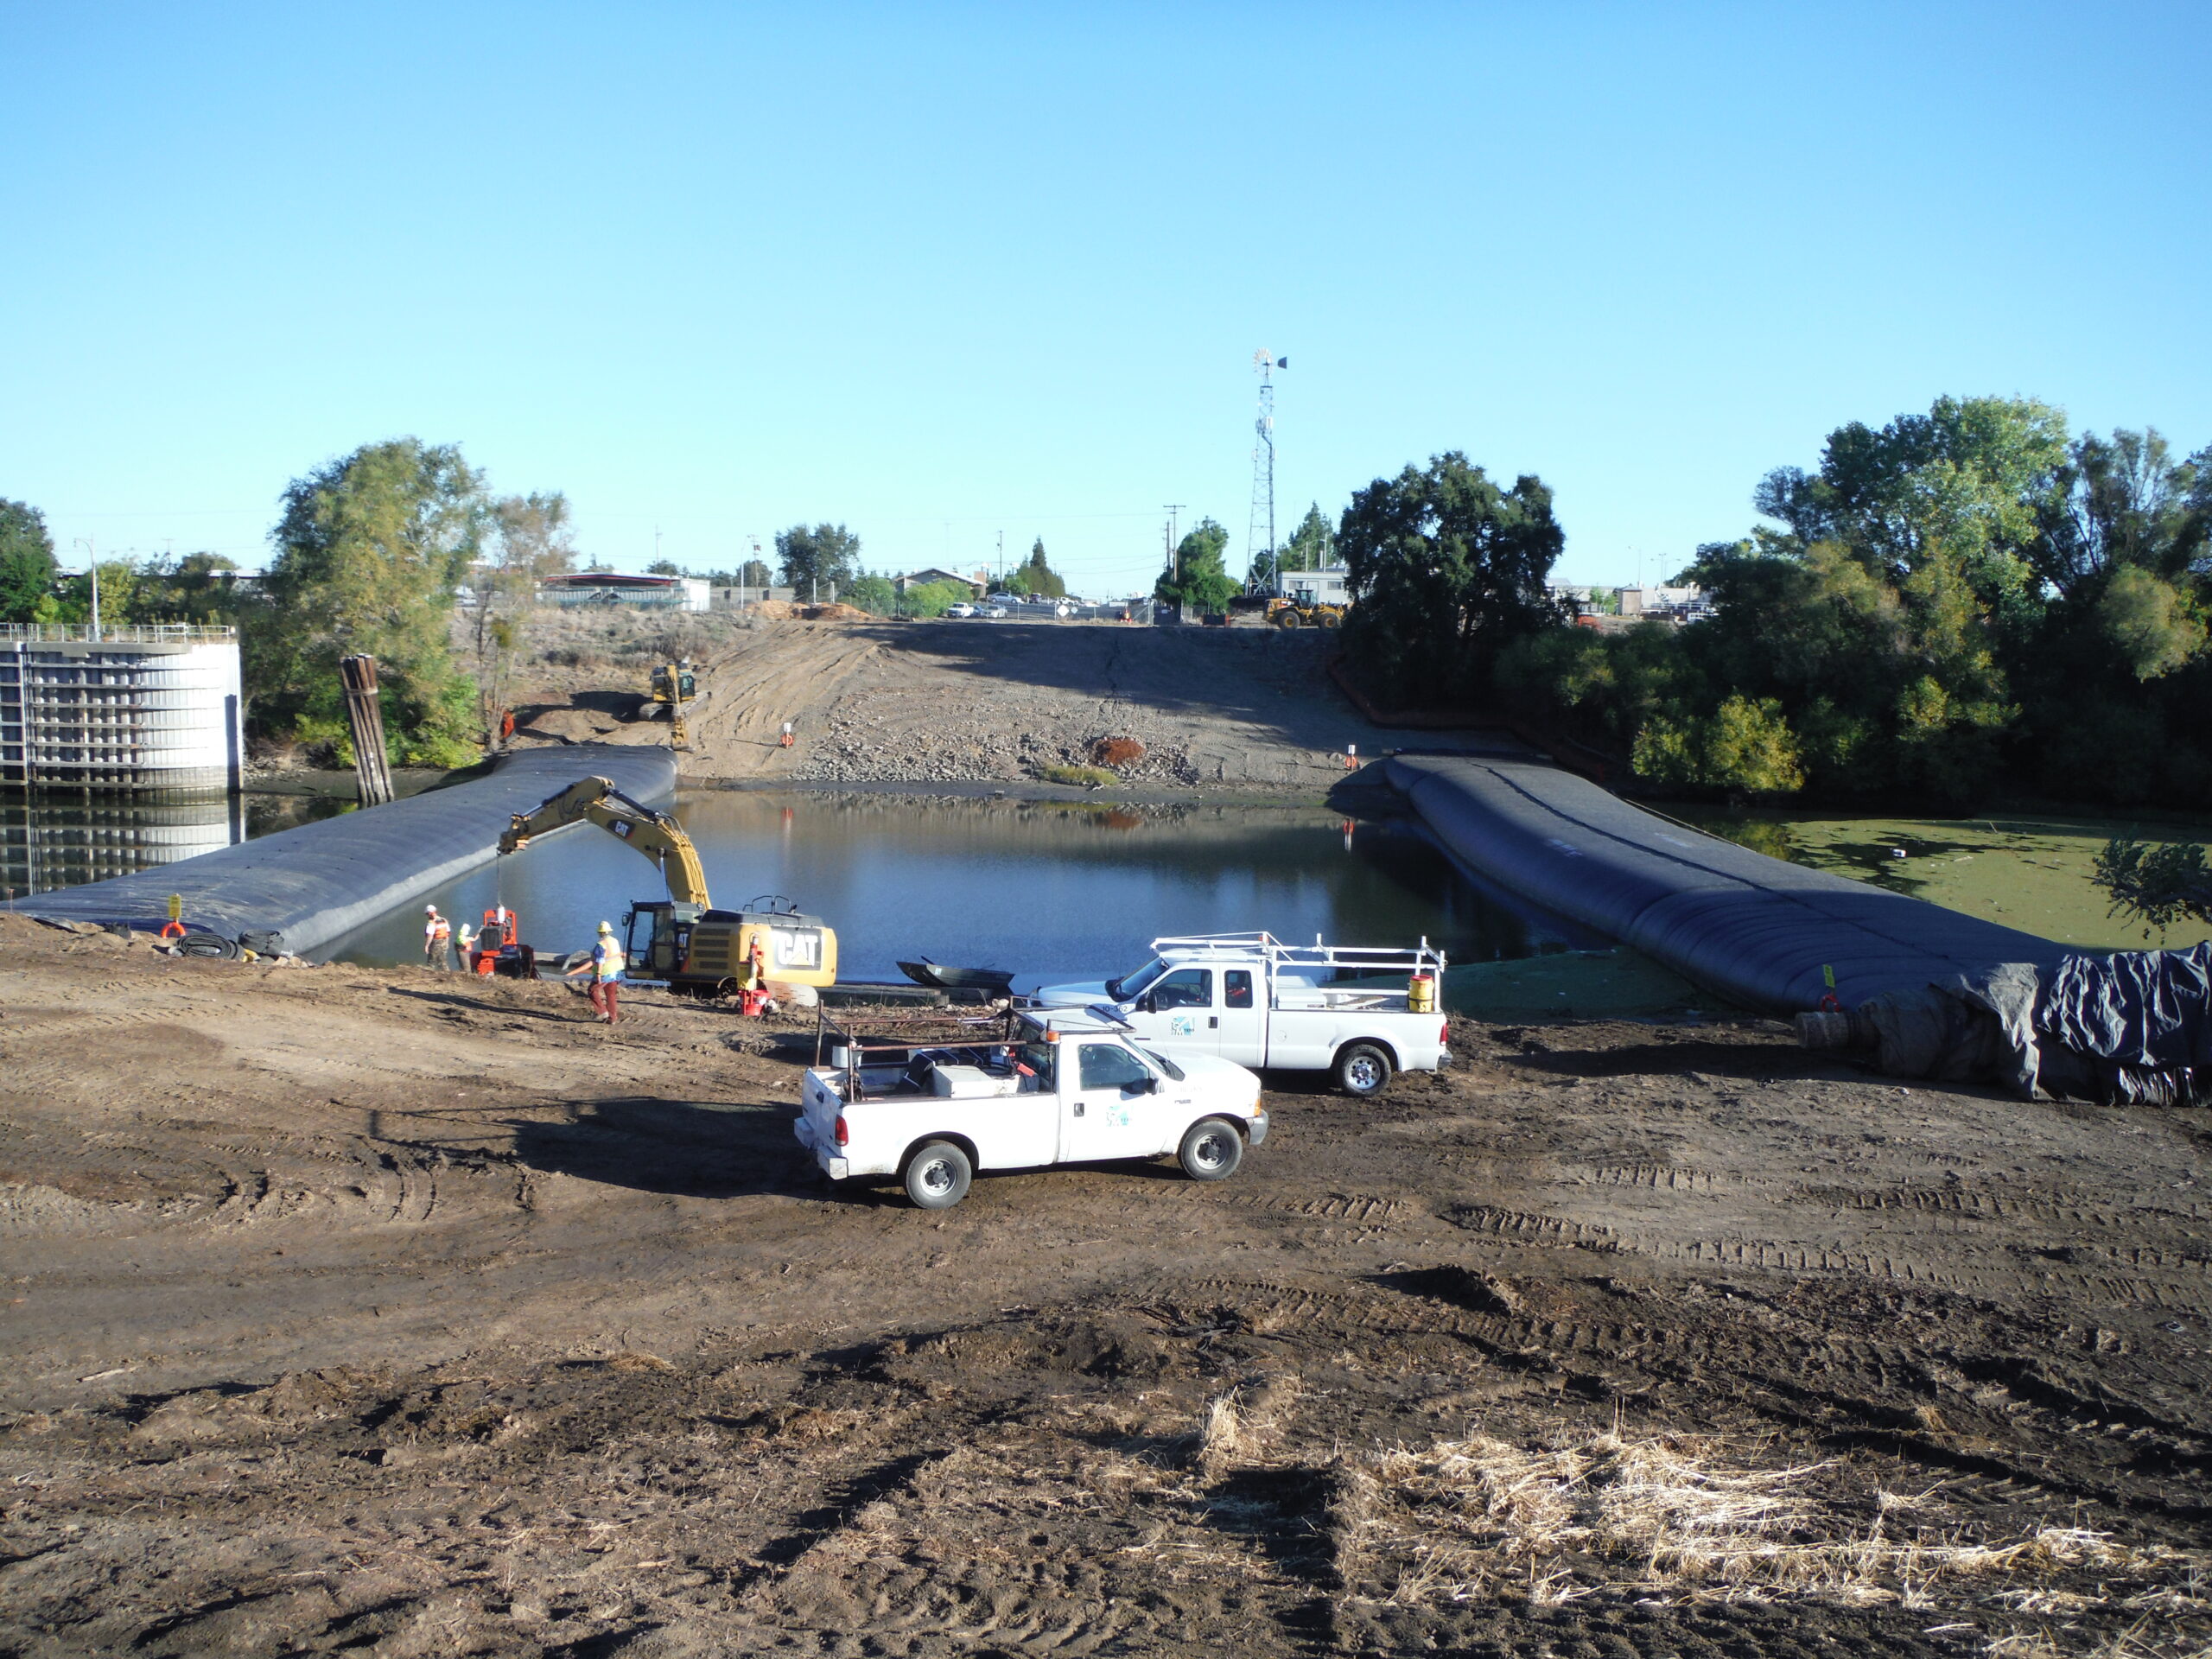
245,438 -> 491,766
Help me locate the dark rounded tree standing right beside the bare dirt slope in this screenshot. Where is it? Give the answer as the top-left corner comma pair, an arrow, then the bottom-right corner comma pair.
1336,451 -> 1566,702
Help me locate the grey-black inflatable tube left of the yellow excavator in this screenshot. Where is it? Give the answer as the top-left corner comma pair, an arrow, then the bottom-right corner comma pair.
17,743 -> 677,953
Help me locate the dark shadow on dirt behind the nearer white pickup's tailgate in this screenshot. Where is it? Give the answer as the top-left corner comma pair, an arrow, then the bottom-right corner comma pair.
509,1095 -> 827,1201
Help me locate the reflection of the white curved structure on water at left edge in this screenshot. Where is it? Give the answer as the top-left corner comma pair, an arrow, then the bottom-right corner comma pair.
0,787 -> 245,898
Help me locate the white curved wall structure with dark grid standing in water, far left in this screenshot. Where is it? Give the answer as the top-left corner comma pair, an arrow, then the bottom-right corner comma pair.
0,624 -> 245,791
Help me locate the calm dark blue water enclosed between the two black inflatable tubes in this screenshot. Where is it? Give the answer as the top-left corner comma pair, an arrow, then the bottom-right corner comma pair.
332,790 -> 1564,988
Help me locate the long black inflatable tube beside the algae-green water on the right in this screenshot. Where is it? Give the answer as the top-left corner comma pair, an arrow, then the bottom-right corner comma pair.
1382,754 -> 2066,1015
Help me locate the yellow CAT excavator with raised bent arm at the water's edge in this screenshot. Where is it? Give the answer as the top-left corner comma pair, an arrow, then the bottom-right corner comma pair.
500,779 -> 836,995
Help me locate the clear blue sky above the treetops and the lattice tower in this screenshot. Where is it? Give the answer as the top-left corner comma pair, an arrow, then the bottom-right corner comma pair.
0,0 -> 2212,593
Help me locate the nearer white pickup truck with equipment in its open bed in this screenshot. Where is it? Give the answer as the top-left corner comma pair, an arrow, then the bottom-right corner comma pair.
794,1008 -> 1268,1210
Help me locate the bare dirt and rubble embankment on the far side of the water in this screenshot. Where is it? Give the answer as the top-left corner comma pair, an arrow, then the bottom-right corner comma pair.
518,621 -> 1365,791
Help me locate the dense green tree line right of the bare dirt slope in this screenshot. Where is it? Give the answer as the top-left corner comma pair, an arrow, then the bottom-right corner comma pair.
1336,398 -> 2212,810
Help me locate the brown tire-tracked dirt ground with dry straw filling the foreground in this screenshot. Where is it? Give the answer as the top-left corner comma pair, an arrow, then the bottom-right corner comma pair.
0,918 -> 2212,1659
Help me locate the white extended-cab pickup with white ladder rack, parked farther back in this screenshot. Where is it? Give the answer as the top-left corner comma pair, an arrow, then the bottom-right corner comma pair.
1033,933 -> 1451,1095
